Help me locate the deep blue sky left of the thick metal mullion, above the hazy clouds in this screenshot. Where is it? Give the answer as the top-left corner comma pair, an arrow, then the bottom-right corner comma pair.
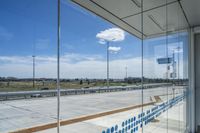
0,0 -> 57,55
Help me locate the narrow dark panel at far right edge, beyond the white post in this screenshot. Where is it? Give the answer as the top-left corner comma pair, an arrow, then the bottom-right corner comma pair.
194,34 -> 200,132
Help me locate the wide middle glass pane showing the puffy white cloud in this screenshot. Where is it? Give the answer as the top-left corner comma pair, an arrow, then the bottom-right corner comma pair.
57,0 -> 142,133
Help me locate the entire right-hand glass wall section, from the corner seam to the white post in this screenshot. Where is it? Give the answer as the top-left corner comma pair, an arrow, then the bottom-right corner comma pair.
142,0 -> 188,133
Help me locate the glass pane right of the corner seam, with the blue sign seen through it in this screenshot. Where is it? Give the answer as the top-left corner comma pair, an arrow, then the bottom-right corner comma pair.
141,0 -> 170,133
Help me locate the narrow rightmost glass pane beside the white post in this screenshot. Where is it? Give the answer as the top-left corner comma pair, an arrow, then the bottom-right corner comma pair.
168,3 -> 188,133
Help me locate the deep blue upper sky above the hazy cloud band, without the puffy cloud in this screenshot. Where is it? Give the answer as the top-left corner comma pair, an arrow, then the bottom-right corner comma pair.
0,0 -> 140,56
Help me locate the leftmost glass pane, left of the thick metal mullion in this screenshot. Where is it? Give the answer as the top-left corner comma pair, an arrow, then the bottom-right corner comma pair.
0,0 -> 57,132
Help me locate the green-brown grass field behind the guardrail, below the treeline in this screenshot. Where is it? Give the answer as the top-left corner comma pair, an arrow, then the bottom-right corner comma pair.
0,81 -> 134,92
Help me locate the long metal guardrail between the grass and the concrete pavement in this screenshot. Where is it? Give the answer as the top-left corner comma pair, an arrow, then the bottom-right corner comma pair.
0,83 -> 172,100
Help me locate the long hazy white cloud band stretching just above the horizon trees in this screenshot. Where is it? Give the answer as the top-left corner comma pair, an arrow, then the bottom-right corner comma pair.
0,54 -> 183,78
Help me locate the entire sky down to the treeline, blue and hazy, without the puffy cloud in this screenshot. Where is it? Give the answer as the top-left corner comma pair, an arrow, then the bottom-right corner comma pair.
0,0 -> 188,78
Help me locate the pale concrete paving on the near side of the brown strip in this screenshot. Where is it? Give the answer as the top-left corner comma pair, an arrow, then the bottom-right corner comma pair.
38,102 -> 185,133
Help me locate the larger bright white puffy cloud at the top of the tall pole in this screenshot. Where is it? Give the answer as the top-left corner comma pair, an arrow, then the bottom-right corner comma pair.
96,28 -> 125,42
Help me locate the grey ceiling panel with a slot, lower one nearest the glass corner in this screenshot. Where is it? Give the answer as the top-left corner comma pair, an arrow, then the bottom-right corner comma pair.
123,2 -> 188,36
